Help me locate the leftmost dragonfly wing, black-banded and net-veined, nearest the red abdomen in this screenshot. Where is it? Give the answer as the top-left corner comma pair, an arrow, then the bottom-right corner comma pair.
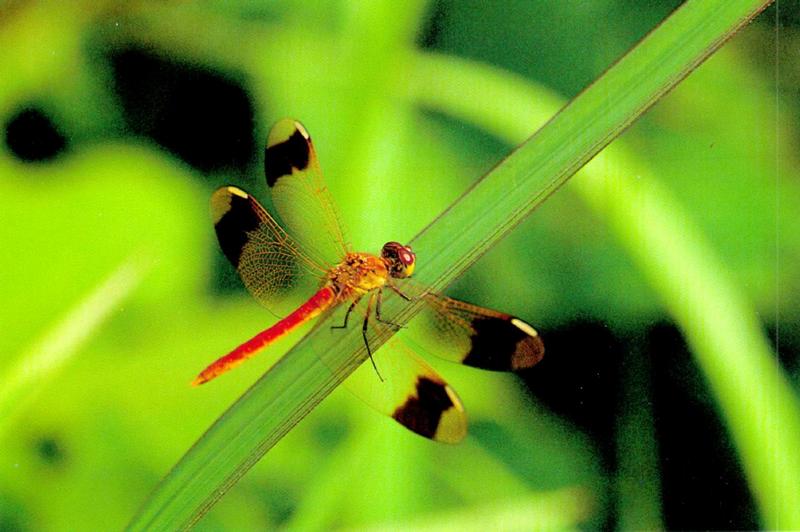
211,186 -> 325,315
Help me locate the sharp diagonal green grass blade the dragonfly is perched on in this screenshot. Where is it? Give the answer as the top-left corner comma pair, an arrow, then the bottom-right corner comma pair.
126,0 -> 765,530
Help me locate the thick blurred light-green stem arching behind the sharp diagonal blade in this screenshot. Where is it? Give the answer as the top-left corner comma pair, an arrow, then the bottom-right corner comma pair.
411,28 -> 800,528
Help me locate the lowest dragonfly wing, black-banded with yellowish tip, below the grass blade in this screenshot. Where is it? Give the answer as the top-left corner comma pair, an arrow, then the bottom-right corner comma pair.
344,340 -> 467,443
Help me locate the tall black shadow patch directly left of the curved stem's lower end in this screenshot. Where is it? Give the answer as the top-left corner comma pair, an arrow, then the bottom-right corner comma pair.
647,325 -> 759,530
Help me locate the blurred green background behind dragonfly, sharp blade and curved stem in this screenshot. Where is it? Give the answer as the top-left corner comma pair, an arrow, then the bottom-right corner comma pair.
0,0 -> 800,530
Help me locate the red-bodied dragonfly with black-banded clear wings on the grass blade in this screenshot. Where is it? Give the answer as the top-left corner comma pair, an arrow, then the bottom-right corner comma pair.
192,118 -> 544,443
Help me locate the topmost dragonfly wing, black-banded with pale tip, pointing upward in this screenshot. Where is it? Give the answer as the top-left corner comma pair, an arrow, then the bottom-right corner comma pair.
264,118 -> 349,264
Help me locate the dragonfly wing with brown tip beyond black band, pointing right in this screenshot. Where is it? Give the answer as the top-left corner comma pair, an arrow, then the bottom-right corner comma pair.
408,293 -> 544,371
